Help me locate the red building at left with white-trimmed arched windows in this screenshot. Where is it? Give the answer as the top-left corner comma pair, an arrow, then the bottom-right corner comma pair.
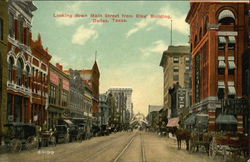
5,0 -> 37,124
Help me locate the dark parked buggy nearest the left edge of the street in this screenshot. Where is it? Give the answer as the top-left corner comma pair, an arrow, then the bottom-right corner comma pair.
4,123 -> 39,152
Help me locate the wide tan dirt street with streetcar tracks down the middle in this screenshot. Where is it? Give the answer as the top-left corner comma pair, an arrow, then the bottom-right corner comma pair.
0,130 -> 229,162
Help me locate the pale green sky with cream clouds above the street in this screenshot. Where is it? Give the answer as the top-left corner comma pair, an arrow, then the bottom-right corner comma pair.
32,1 -> 189,115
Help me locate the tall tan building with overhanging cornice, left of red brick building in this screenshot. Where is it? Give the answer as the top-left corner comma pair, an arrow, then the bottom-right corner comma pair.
160,46 -> 191,116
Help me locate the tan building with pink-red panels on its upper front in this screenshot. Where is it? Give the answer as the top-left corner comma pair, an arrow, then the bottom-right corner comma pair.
48,63 -> 70,129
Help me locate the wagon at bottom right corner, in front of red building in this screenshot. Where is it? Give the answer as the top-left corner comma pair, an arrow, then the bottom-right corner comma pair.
209,134 -> 249,161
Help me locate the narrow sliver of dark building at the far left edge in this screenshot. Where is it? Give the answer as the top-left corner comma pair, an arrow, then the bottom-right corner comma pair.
0,1 -> 9,143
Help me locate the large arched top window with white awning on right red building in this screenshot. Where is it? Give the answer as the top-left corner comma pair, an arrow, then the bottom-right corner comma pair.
218,10 -> 235,25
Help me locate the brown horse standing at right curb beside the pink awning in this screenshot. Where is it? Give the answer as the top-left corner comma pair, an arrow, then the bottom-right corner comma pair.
175,129 -> 191,150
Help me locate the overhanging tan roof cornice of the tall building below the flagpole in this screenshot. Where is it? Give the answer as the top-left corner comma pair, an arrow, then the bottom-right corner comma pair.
160,45 -> 190,66
